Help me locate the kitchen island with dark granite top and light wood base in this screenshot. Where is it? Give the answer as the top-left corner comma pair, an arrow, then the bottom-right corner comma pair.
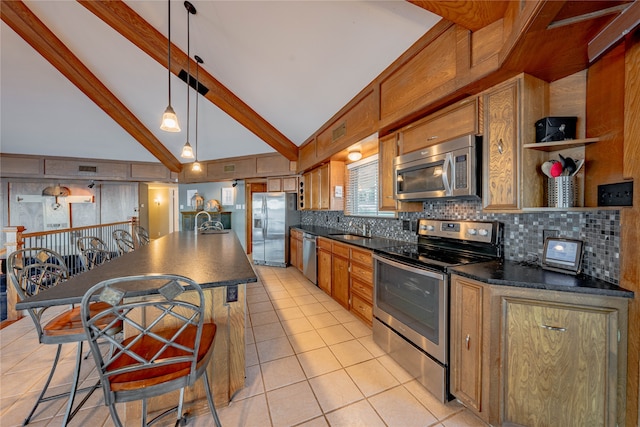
16,230 -> 257,425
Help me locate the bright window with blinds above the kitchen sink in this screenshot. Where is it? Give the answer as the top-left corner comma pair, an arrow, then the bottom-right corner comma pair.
345,154 -> 395,218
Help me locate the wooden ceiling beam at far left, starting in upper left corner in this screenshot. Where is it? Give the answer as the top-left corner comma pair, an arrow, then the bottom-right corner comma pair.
0,1 -> 182,173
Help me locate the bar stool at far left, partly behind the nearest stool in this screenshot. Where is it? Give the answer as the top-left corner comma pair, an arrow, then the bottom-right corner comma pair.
7,248 -> 122,425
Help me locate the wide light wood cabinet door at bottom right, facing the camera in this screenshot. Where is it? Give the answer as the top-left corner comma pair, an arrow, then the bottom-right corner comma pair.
503,298 -> 617,427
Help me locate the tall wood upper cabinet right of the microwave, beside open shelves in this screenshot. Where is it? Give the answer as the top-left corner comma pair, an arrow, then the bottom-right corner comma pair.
483,74 -> 548,210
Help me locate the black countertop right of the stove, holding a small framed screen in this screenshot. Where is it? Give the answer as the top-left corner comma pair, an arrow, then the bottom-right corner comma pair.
449,261 -> 634,298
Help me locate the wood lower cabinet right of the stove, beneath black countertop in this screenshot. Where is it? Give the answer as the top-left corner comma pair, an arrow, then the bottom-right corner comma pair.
451,274 -> 628,427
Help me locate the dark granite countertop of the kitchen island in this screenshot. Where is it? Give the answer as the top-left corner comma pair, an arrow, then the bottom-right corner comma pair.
16,231 -> 258,310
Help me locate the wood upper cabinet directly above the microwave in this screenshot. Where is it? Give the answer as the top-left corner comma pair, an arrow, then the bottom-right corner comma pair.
399,97 -> 478,154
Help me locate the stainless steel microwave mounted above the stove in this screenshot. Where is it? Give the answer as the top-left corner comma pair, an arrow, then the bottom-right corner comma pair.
393,135 -> 482,200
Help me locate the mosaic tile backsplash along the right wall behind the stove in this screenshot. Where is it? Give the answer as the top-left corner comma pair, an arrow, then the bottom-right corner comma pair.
301,200 -> 620,284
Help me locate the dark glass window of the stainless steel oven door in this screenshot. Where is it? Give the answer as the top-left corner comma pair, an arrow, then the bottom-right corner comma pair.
376,262 -> 443,345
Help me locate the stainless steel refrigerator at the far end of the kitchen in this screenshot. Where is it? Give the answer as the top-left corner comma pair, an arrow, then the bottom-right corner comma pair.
251,193 -> 300,267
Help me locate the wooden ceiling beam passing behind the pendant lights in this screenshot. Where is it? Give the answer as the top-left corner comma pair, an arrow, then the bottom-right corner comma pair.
78,0 -> 298,161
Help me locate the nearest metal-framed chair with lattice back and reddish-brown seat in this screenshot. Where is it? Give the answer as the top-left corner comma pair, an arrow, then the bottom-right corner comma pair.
81,274 -> 220,427
